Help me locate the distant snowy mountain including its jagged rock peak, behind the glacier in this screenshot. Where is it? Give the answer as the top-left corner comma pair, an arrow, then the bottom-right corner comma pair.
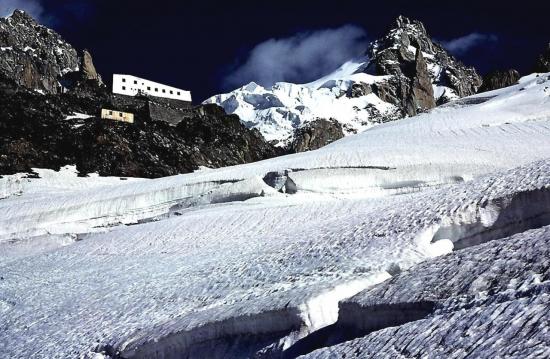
205,17 -> 481,149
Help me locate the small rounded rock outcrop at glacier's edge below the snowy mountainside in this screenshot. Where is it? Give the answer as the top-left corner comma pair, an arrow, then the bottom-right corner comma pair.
289,118 -> 344,153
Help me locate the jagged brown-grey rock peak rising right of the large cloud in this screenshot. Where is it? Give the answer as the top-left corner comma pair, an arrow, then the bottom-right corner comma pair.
361,16 -> 481,116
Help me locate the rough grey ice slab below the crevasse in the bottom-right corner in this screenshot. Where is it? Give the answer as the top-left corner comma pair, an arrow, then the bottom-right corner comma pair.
306,226 -> 550,358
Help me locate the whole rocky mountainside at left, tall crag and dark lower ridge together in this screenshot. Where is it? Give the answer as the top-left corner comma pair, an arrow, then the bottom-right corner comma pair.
0,11 -> 279,177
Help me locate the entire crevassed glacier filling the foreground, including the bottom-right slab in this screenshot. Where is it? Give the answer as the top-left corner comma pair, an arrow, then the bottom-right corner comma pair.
0,74 -> 550,359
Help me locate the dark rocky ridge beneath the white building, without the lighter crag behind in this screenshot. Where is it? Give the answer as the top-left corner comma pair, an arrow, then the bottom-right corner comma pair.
0,91 -> 278,178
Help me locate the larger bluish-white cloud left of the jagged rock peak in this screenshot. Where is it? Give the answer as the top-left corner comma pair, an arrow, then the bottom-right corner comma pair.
224,25 -> 367,89
